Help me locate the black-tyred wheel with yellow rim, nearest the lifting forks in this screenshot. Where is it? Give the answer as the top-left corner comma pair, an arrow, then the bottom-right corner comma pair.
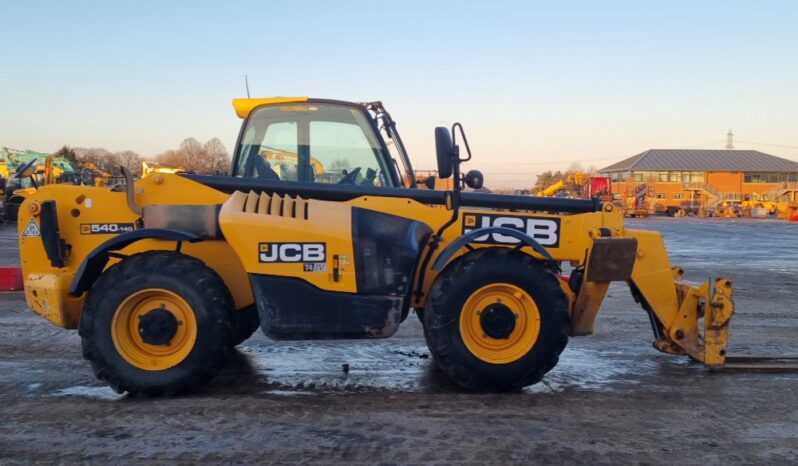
424,248 -> 570,389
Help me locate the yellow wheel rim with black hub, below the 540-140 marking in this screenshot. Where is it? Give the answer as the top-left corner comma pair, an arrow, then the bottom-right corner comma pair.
111,288 -> 197,371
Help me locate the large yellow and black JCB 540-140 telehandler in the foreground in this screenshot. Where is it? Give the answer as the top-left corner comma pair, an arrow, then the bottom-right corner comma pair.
14,97 -> 764,394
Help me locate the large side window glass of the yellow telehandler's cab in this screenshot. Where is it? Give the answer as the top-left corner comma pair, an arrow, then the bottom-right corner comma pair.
233,103 -> 399,186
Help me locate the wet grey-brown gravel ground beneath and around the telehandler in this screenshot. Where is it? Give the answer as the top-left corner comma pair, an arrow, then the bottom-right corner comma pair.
0,219 -> 798,465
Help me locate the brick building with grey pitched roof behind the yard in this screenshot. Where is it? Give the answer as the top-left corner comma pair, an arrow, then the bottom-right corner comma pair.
599,149 -> 798,212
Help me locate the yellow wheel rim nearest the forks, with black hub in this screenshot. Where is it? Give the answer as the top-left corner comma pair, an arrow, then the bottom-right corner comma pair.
460,283 -> 540,364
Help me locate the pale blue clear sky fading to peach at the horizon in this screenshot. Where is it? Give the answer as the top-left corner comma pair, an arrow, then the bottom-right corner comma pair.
0,0 -> 798,186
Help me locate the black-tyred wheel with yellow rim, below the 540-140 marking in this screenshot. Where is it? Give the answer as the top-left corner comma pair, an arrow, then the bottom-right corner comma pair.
80,251 -> 234,395
